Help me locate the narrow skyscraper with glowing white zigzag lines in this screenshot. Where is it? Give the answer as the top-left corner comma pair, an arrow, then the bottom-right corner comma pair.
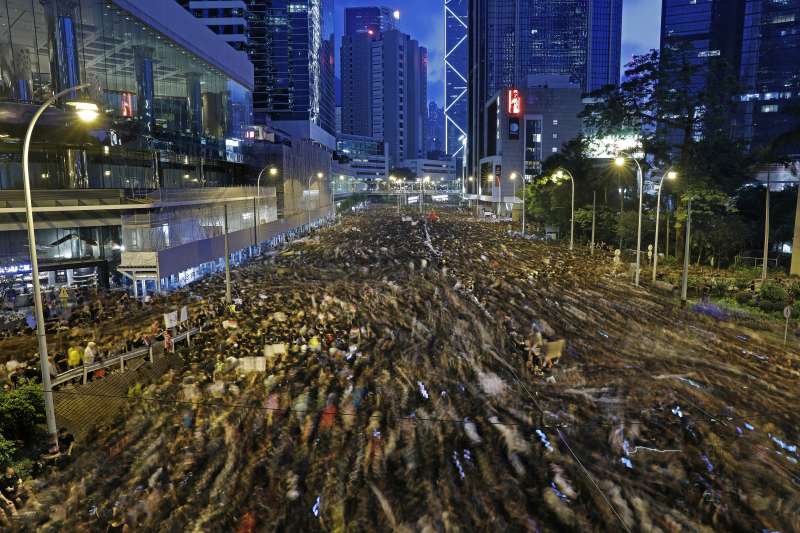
444,0 -> 469,156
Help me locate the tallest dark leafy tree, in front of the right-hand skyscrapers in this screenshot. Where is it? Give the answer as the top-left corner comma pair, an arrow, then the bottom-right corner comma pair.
584,48 -> 764,256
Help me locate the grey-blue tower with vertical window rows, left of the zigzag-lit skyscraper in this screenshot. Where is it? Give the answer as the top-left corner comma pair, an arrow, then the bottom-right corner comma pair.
340,26 -> 428,165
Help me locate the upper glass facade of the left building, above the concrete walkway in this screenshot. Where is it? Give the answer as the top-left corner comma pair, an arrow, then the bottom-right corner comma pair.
0,0 -> 252,189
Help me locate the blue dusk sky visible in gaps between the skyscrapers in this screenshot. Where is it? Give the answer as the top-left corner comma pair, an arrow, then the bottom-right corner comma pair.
334,0 -> 661,105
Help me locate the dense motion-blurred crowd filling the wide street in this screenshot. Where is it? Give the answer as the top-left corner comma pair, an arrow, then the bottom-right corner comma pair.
7,208 -> 800,532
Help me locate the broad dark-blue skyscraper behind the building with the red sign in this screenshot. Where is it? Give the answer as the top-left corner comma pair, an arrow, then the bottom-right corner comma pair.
467,0 -> 620,179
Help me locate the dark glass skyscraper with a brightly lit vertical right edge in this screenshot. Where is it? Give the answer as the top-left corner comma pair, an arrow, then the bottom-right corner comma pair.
247,0 -> 336,148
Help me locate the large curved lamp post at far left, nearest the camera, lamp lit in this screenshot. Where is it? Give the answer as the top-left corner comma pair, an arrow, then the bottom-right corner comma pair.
22,83 -> 99,453
